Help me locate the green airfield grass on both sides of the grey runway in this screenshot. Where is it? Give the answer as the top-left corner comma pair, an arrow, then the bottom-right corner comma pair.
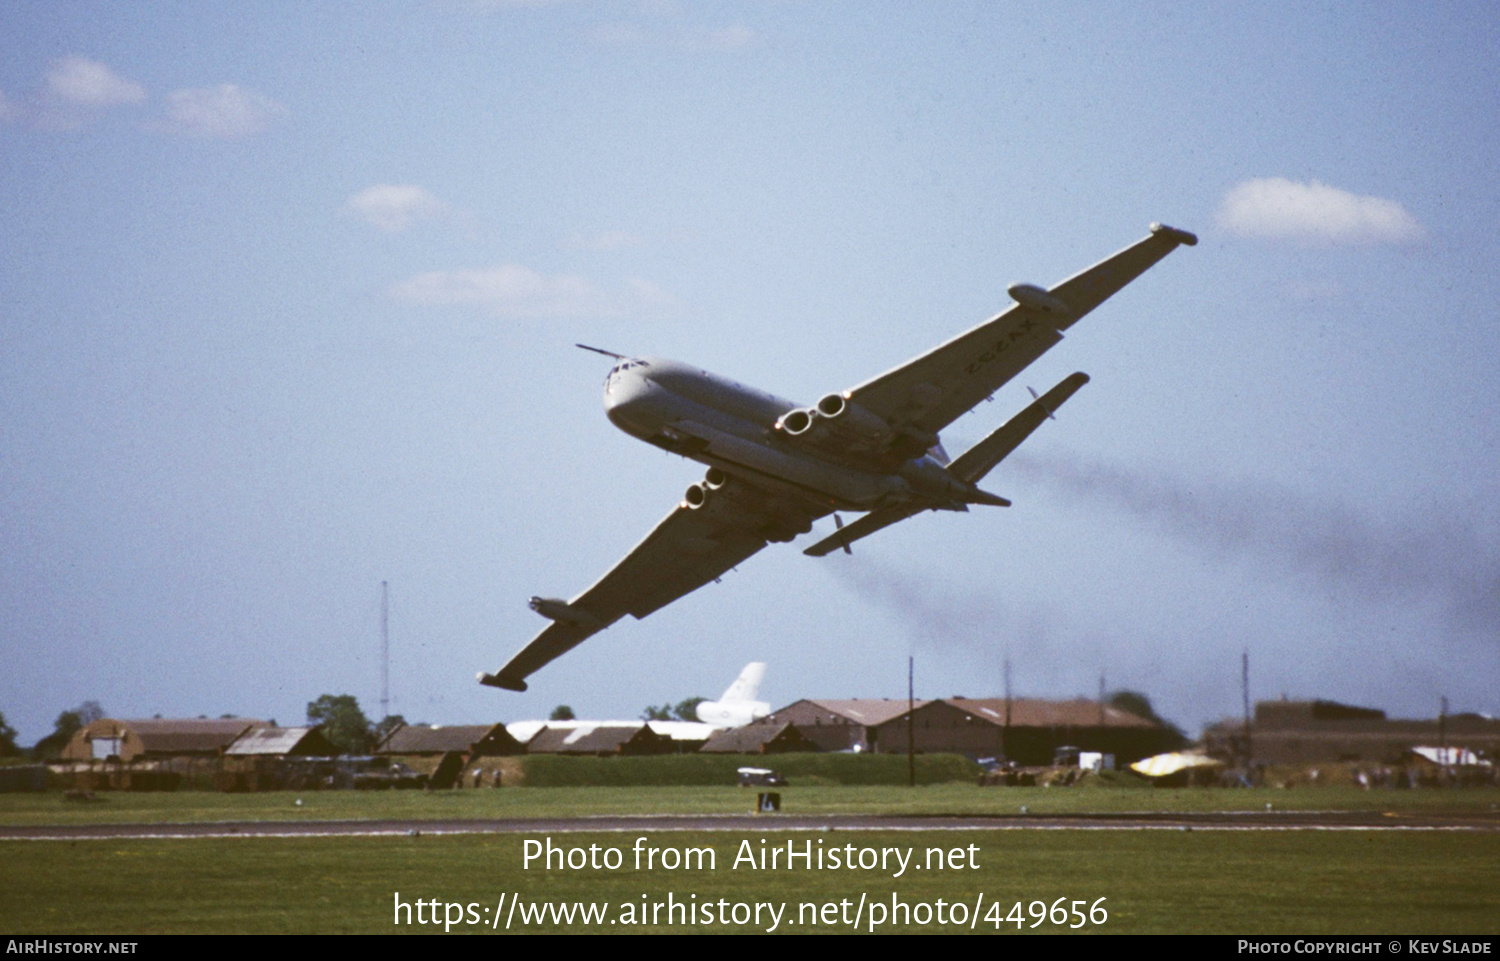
0,783 -> 1500,934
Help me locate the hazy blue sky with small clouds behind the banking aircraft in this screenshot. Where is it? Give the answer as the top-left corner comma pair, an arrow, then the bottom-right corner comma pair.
0,0 -> 1500,742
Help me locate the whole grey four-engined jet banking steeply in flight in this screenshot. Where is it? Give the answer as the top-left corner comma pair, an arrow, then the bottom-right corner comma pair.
479,223 -> 1199,691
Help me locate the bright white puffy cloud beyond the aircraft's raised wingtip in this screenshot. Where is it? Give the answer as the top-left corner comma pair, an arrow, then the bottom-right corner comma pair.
1218,177 -> 1425,244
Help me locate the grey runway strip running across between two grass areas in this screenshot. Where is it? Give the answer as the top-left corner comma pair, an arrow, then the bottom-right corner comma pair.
0,811 -> 1500,841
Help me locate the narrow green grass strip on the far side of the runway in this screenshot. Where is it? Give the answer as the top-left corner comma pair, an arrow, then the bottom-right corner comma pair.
0,780 -> 1500,825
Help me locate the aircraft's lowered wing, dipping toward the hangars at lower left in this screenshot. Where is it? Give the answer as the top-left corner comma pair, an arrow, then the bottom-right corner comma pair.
480,481 -> 813,691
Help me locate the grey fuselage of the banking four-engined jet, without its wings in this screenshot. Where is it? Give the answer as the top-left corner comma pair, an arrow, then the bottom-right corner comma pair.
605,357 -> 978,511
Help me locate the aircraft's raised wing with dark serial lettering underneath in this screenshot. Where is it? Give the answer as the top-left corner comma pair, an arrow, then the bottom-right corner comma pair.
846,223 -> 1197,437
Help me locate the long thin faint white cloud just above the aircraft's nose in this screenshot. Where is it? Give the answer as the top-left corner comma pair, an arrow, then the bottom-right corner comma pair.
390,264 -> 678,319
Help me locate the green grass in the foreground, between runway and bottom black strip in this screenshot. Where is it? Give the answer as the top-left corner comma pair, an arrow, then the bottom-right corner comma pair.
0,831 -> 1500,934
